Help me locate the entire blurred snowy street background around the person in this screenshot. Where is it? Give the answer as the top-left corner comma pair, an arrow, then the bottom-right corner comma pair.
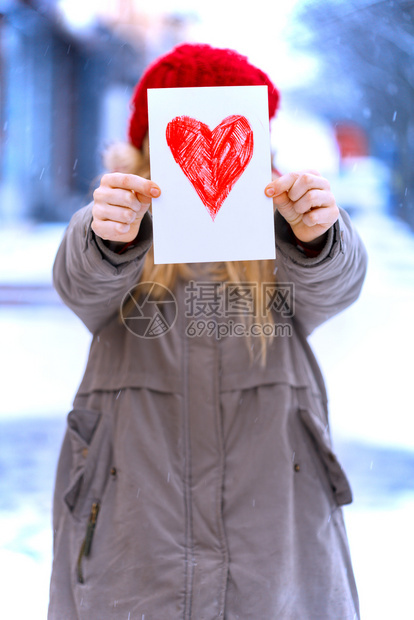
0,0 -> 414,620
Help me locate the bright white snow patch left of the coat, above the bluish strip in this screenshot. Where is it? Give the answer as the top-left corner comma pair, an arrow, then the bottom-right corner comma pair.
0,305 -> 91,419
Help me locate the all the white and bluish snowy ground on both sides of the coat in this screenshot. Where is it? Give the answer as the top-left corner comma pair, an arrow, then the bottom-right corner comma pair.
0,212 -> 414,620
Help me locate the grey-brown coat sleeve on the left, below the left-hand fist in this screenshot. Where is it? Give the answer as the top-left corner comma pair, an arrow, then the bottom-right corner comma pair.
53,205 -> 152,333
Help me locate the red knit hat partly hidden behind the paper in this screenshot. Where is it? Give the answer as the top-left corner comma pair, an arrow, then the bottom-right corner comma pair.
128,43 -> 279,149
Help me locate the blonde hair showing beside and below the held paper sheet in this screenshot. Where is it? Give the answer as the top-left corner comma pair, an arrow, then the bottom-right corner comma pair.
103,136 -> 276,365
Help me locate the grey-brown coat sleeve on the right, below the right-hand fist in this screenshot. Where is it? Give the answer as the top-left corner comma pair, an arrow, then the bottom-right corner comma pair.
275,210 -> 367,335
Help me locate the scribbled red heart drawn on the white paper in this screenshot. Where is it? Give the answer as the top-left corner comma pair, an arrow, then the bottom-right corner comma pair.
166,116 -> 253,222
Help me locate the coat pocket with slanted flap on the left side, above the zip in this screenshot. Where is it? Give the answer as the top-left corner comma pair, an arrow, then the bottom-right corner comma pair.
64,409 -> 112,520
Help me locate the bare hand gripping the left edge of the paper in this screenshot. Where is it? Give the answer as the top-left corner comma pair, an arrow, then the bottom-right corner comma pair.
92,172 -> 161,243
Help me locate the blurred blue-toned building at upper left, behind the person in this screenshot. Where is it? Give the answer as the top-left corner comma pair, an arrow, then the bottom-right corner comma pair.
0,0 -> 189,222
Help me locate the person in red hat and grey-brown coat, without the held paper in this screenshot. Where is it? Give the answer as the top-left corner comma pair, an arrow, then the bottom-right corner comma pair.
49,44 -> 366,620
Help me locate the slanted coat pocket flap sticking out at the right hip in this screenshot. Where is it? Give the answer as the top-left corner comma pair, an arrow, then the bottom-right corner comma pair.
299,409 -> 352,506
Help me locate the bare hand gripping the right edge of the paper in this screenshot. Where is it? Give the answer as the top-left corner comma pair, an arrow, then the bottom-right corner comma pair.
265,170 -> 339,245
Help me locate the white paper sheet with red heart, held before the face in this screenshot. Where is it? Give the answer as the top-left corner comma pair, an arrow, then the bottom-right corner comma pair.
148,86 -> 275,264
